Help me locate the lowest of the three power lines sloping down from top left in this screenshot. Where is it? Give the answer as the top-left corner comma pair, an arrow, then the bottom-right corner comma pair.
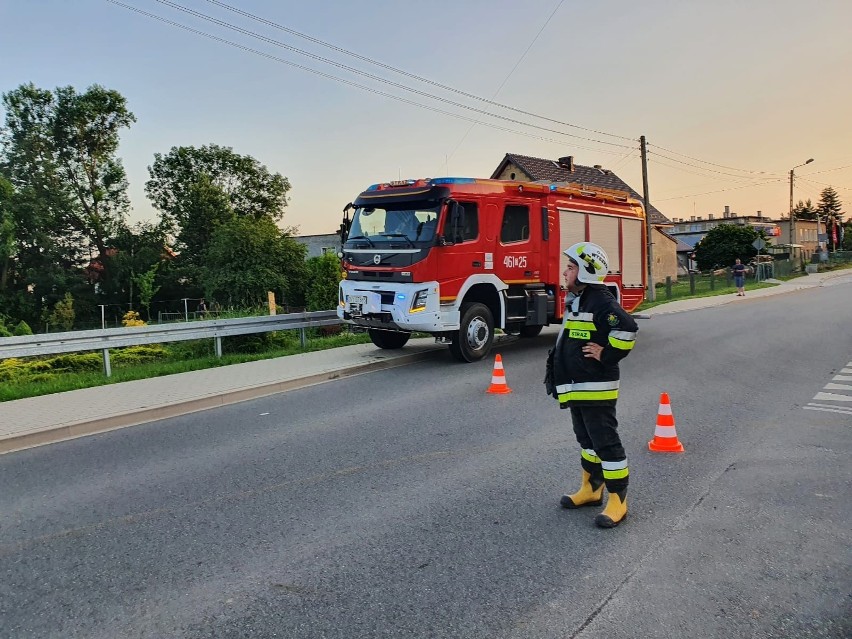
106,0 -> 630,155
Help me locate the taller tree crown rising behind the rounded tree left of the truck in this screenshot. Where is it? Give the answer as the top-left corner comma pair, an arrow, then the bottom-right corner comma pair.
145,144 -> 290,250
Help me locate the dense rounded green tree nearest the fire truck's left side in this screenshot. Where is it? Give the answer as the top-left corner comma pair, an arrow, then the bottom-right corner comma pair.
200,216 -> 307,308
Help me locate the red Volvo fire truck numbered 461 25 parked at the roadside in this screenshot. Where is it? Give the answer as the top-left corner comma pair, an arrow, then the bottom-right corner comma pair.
337,178 -> 646,362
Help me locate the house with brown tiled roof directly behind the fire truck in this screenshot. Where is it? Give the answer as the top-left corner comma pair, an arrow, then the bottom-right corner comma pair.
491,153 -> 678,283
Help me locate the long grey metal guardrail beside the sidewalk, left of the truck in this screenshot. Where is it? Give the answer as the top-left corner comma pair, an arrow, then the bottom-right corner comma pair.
0,311 -> 340,377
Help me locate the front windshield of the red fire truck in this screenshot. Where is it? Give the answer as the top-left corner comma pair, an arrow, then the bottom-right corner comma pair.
349,202 -> 441,245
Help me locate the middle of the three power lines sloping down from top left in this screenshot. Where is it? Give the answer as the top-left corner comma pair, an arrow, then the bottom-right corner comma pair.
146,0 -> 630,148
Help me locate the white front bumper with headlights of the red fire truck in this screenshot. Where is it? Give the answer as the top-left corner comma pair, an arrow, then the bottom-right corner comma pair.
337,280 -> 442,333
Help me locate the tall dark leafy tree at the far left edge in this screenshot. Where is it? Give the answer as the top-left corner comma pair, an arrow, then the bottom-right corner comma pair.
0,84 -> 135,325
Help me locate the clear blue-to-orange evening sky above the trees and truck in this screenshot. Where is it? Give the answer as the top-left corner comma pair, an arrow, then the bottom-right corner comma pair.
0,0 -> 852,234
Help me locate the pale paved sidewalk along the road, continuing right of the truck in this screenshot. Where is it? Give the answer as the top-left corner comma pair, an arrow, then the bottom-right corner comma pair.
0,270 -> 852,454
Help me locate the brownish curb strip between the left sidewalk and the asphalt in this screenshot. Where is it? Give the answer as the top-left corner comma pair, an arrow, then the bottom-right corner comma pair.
0,347 -> 446,455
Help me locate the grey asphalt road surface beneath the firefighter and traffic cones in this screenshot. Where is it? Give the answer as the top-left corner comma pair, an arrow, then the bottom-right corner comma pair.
0,281 -> 852,639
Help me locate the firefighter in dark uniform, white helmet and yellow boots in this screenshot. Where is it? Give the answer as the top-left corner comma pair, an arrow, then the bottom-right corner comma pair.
545,242 -> 638,528
